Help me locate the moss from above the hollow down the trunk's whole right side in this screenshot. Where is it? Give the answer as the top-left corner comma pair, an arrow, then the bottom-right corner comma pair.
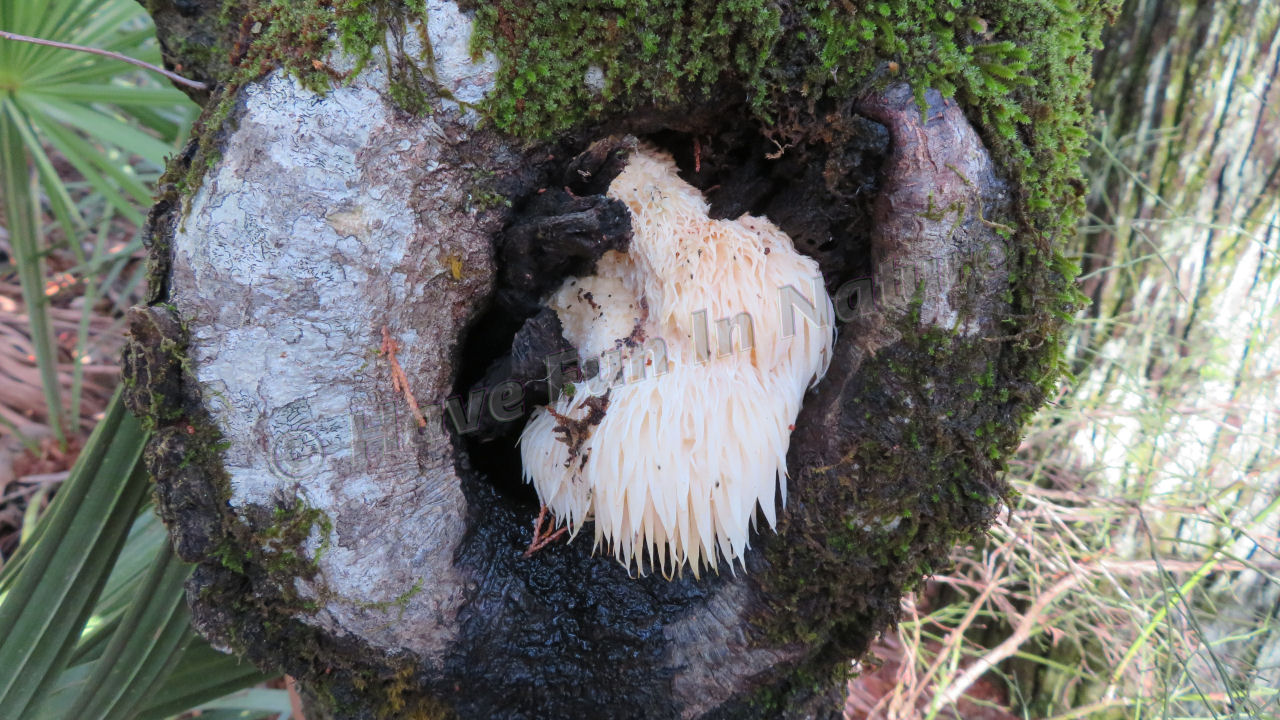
455,0 -> 1119,705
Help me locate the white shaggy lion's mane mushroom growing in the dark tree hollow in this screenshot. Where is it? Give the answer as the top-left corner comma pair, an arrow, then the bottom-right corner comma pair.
521,142 -> 835,574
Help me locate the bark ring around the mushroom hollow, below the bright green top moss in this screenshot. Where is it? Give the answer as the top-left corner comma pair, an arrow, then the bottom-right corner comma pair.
127,0 -> 1090,717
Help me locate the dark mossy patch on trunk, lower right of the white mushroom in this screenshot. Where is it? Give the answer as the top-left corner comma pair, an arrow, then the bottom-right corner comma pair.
759,320 -> 1021,662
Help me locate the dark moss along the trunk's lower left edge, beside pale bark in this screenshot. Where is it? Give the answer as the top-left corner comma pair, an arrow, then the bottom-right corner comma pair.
133,322 -> 422,719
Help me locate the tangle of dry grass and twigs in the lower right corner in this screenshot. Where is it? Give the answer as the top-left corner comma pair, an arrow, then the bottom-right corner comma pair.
846,229 -> 1280,720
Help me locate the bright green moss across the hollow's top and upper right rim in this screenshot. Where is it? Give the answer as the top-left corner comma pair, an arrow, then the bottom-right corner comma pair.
465,0 -> 1120,386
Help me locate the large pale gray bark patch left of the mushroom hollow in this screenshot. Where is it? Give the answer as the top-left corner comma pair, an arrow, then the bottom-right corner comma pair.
172,63 -> 492,656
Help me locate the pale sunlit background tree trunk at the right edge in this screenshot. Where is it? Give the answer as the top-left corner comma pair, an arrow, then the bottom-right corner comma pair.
1016,0 -> 1280,716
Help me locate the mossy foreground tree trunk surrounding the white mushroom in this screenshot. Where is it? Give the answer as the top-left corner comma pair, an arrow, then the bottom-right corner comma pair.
127,0 -> 1106,717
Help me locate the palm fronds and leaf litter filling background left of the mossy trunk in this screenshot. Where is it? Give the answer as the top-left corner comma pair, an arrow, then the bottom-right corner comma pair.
0,0 -> 289,720
